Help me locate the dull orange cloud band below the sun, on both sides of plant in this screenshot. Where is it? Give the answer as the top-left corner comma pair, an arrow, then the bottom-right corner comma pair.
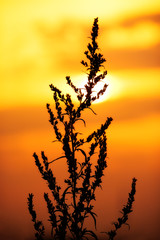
0,95 -> 160,136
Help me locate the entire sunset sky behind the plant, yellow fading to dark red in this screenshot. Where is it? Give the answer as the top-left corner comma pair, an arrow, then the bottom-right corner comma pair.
0,0 -> 160,240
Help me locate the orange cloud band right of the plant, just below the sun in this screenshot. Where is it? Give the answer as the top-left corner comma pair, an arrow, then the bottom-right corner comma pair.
93,98 -> 160,122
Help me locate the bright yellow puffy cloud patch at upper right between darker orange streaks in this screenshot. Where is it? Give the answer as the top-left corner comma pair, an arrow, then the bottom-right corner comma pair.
103,21 -> 160,49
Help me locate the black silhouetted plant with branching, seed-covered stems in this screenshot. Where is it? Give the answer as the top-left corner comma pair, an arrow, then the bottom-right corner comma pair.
28,18 -> 136,240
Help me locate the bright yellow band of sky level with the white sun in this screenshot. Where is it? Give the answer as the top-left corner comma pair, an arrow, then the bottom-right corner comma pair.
0,69 -> 160,109
